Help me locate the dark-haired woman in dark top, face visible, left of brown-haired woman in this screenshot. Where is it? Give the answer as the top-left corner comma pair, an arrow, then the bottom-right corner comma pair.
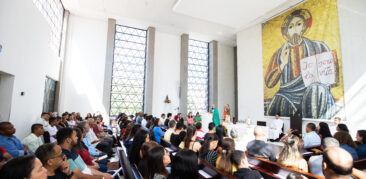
199,134 -> 219,166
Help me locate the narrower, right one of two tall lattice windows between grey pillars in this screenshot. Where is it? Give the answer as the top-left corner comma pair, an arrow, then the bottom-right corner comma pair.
187,39 -> 208,113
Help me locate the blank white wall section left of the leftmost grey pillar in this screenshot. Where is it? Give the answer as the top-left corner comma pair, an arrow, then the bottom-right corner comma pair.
59,14 -> 109,116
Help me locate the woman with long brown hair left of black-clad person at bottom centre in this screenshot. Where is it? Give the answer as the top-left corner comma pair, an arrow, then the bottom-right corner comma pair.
216,138 -> 237,174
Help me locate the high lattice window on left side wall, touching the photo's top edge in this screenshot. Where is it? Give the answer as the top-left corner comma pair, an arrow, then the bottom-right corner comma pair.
33,0 -> 65,55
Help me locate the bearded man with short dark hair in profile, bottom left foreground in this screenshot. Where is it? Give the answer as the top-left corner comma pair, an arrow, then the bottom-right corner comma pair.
35,143 -> 75,179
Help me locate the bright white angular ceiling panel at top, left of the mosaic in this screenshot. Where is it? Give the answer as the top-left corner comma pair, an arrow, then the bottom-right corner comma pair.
174,0 -> 286,29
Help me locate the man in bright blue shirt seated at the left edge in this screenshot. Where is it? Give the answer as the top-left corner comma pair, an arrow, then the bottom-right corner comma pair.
0,122 -> 28,158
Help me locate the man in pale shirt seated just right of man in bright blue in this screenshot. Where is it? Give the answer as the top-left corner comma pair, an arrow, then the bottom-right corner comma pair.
22,124 -> 44,153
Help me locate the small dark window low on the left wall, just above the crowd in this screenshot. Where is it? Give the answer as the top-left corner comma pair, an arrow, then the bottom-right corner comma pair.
43,77 -> 57,112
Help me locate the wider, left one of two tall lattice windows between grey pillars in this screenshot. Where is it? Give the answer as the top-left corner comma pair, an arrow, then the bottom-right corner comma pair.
109,25 -> 147,116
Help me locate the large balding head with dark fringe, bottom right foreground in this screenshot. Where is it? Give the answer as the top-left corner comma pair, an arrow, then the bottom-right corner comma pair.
323,147 -> 353,178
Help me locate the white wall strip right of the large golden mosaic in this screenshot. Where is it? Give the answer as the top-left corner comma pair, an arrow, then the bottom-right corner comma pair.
338,0 -> 366,136
